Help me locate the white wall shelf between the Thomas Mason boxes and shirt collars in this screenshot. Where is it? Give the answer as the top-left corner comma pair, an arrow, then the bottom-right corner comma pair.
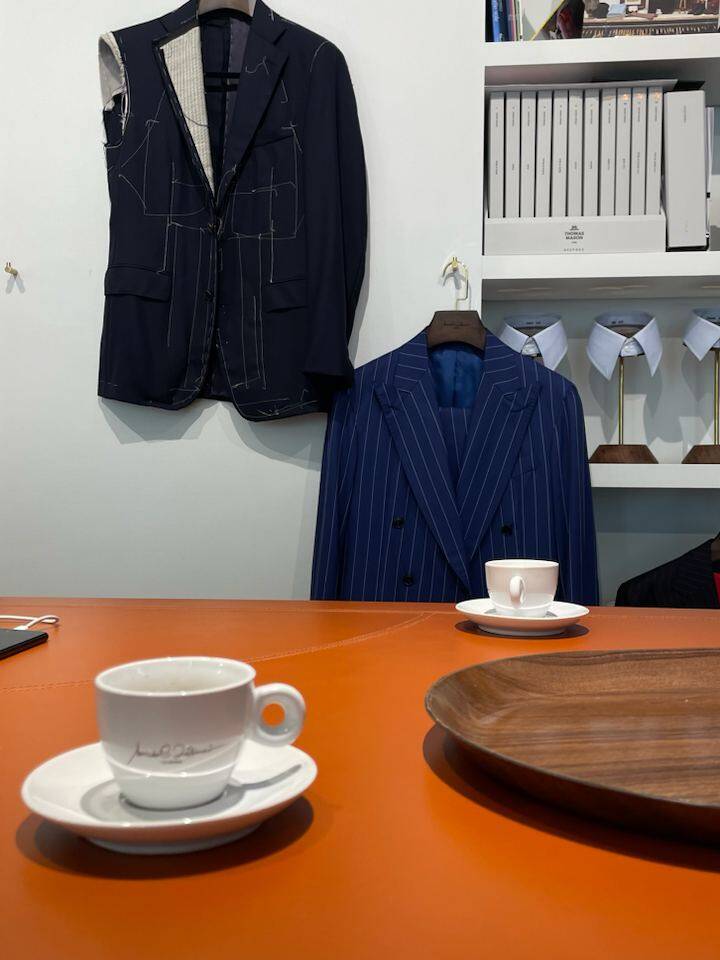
482,251 -> 720,300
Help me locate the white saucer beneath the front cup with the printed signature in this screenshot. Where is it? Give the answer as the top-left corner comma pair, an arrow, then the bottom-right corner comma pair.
22,741 -> 317,854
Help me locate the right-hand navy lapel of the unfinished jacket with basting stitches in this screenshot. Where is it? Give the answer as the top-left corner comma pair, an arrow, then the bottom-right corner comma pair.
218,0 -> 287,207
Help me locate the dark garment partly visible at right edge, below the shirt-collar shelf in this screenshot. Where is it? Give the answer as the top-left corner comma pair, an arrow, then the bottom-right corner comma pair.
615,536 -> 720,610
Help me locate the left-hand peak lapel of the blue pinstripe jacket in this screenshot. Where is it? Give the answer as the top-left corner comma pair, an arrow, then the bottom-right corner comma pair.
375,333 -> 470,590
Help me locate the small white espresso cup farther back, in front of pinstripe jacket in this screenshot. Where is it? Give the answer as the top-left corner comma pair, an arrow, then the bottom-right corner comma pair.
485,560 -> 559,617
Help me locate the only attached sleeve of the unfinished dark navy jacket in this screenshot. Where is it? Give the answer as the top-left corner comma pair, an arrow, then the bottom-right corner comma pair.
302,42 -> 367,389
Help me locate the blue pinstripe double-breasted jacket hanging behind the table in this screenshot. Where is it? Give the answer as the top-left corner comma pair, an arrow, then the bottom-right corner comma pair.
312,333 -> 597,603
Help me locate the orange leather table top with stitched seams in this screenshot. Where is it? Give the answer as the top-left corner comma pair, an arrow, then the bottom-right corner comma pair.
0,598 -> 720,960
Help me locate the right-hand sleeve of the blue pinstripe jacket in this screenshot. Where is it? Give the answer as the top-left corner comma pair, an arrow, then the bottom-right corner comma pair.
559,384 -> 599,606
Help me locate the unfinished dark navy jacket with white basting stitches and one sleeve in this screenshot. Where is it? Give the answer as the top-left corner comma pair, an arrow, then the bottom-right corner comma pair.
99,0 -> 366,420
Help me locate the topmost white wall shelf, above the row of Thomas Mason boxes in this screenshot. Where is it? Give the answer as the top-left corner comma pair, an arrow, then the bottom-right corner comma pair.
483,33 -> 720,104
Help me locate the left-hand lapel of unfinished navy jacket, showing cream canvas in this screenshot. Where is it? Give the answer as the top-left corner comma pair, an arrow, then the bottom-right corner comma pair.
155,0 -> 215,195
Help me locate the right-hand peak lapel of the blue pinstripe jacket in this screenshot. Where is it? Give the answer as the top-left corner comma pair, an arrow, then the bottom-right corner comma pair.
457,333 -> 539,560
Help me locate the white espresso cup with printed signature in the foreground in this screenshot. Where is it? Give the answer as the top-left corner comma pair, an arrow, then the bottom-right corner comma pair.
95,657 -> 305,810
